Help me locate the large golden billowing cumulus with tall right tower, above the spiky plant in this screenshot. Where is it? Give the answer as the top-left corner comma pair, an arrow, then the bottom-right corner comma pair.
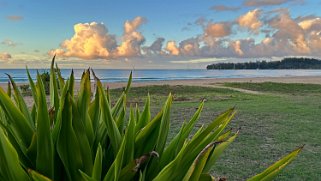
48,17 -> 145,60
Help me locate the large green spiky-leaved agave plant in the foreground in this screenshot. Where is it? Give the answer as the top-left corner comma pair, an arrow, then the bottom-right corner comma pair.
0,55 -> 302,181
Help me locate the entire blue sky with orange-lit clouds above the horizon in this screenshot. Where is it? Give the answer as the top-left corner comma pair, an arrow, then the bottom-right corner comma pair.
0,0 -> 321,69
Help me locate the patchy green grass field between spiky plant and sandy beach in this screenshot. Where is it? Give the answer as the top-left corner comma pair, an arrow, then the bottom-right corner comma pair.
111,83 -> 321,181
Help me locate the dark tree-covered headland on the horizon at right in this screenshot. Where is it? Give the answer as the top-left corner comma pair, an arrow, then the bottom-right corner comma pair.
206,57 -> 321,69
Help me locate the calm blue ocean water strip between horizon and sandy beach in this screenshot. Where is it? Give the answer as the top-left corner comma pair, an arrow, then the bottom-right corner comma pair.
0,69 -> 321,83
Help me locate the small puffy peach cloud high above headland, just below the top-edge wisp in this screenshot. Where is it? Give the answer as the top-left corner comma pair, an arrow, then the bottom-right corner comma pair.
237,9 -> 262,33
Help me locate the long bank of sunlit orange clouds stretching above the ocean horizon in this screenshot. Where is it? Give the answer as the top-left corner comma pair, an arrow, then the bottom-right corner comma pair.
49,9 -> 321,60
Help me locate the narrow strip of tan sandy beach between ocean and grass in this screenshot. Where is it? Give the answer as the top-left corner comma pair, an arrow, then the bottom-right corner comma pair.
0,76 -> 321,90
